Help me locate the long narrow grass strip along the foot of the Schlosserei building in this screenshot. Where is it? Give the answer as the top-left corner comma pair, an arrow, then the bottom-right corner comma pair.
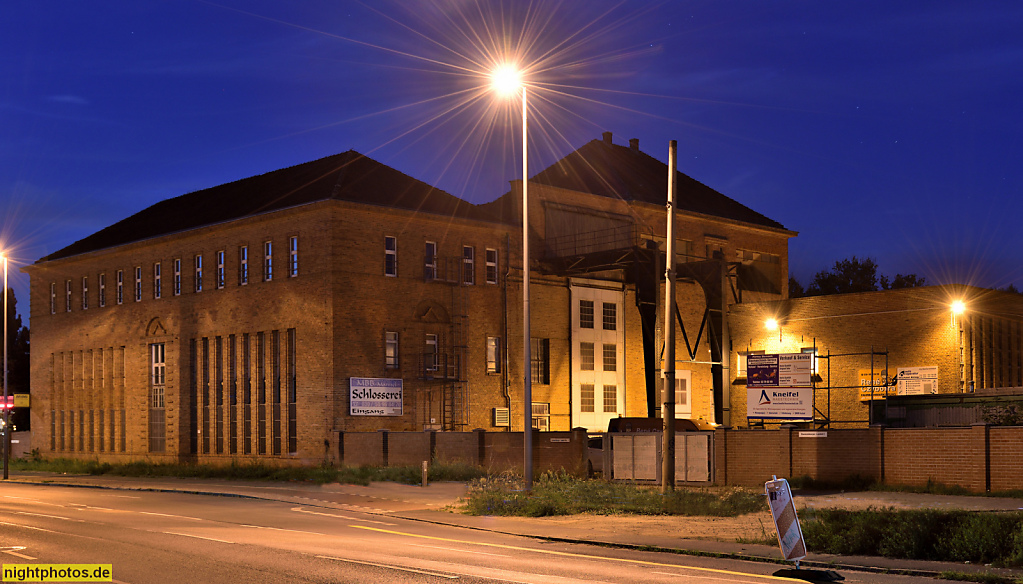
11,457 -> 486,485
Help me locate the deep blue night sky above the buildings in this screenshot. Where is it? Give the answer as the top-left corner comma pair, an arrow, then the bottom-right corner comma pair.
0,0 -> 1023,313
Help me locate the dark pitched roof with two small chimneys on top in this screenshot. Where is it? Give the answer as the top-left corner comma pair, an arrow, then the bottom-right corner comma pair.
482,133 -> 785,229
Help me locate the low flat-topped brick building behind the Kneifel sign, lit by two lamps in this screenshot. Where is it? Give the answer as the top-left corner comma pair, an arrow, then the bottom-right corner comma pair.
728,285 -> 1023,428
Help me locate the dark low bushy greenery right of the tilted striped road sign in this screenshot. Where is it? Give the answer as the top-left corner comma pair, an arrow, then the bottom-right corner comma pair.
800,508 -> 1023,567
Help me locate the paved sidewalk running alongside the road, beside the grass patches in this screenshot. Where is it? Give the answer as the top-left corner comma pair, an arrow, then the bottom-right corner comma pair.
11,471 -> 1023,578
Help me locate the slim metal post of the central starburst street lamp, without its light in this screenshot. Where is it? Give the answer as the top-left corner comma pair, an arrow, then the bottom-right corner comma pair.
522,85 -> 533,491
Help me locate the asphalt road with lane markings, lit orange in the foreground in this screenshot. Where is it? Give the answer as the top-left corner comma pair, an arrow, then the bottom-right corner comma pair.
0,484 -> 932,584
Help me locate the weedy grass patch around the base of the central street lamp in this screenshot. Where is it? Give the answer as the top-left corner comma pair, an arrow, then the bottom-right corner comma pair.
465,473 -> 766,518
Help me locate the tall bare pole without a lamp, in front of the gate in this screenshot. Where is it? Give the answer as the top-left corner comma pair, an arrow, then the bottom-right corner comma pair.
661,140 -> 678,493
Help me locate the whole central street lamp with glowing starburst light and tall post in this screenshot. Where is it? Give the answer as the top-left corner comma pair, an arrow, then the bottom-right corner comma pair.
490,65 -> 533,491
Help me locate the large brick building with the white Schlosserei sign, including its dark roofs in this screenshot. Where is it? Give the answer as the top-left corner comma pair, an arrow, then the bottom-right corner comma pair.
25,133 -> 795,461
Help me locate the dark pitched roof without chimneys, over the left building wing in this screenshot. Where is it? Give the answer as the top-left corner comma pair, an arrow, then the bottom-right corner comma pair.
37,150 -> 493,263
